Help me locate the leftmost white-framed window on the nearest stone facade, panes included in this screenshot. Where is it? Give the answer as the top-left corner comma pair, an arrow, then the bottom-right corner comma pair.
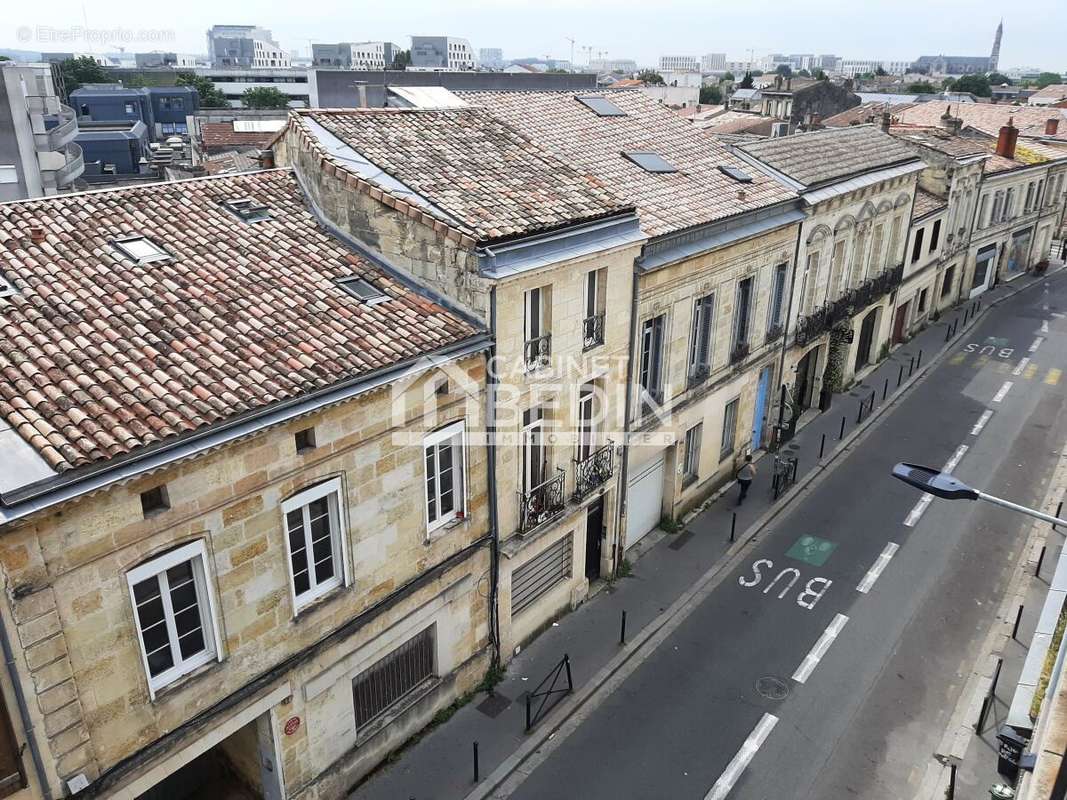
126,541 -> 221,698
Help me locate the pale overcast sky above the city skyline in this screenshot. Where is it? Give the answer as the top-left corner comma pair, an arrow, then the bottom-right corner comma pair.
8,0 -> 1067,70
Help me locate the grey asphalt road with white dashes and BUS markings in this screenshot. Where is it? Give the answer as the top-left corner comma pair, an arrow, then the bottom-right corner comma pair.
512,276 -> 1067,800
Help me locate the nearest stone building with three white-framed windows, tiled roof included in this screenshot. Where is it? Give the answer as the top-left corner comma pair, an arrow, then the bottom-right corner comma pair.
0,170 -> 495,799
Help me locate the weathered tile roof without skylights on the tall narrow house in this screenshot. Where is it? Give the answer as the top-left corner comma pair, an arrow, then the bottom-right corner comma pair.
290,109 -> 627,242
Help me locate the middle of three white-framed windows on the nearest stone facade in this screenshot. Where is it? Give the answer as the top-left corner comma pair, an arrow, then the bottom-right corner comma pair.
282,478 -> 345,611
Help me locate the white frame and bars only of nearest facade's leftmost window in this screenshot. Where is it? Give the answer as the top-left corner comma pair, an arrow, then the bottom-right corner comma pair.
126,540 -> 222,700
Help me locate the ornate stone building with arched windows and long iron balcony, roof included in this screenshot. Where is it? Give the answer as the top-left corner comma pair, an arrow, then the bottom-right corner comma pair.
735,126 -> 923,427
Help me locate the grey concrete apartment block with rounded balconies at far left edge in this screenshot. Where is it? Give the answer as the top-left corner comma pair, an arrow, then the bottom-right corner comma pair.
0,62 -> 85,202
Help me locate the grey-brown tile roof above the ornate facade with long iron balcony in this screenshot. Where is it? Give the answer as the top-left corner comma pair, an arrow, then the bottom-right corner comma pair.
737,125 -> 918,188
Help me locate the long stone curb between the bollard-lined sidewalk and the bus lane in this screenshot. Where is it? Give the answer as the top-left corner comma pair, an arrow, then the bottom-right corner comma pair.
464,267 -> 1067,800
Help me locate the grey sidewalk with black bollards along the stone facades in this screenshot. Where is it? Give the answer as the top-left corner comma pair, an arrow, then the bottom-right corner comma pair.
350,262 -> 1060,800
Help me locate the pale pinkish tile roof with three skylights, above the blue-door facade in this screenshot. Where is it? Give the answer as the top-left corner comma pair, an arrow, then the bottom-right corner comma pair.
459,90 -> 796,236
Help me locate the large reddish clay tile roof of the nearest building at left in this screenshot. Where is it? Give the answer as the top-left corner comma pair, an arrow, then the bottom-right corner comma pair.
0,170 -> 476,471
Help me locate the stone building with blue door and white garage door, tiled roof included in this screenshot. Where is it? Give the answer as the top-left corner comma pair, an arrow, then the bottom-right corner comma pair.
461,90 -> 803,550
